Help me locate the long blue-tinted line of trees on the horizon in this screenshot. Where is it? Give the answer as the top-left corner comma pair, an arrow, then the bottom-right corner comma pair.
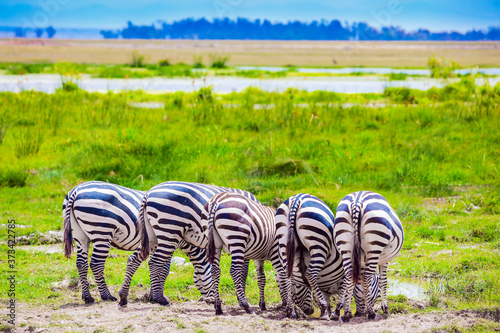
101,18 -> 500,41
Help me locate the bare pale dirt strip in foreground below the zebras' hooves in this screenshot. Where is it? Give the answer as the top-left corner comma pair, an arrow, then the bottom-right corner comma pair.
14,301 -> 492,333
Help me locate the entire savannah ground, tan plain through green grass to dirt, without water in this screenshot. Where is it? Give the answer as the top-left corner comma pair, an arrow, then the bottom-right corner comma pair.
0,39 -> 500,333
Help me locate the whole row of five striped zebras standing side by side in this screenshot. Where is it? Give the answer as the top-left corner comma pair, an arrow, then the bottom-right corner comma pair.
63,181 -> 403,322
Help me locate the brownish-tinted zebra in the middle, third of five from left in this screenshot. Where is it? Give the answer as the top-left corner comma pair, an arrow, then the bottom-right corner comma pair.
202,192 -> 281,315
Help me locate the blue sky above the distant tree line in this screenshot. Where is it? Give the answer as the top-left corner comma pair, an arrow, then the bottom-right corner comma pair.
0,0 -> 500,32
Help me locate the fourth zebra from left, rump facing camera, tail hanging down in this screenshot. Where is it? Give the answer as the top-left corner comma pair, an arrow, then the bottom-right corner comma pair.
275,193 -> 343,320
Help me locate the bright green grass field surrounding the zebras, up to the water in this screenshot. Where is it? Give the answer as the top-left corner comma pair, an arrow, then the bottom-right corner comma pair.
0,78 -> 500,330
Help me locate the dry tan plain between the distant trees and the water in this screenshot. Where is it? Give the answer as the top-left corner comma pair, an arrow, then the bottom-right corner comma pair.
0,39 -> 500,67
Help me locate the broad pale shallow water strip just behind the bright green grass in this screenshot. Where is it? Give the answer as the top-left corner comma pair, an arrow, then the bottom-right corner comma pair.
0,74 -> 500,94
